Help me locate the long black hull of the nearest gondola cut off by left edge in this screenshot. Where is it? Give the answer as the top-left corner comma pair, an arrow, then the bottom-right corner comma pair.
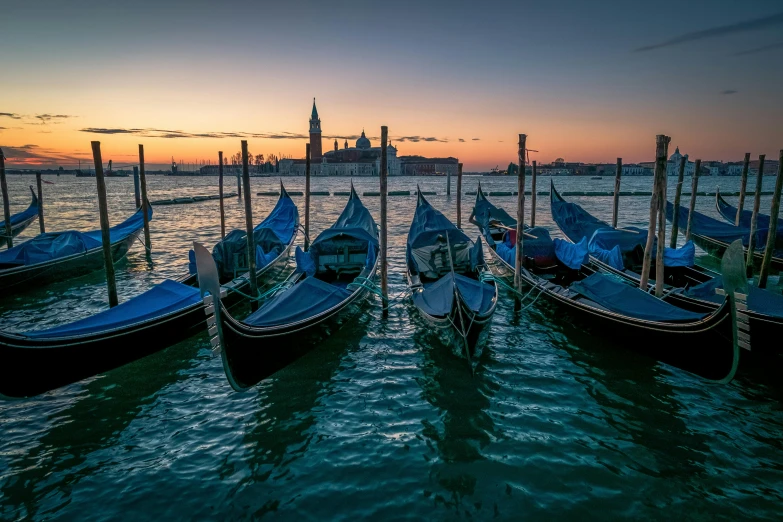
0,234 -> 296,397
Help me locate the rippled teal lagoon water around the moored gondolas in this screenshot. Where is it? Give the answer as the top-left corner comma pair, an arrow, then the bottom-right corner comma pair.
0,176 -> 783,520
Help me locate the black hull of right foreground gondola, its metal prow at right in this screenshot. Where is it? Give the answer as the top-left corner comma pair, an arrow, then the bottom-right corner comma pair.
490,249 -> 740,378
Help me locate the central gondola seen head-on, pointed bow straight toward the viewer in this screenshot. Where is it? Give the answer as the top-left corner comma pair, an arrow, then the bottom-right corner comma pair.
406,190 -> 498,368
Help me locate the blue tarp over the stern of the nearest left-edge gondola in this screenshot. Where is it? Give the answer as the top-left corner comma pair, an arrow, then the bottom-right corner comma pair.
212,189 -> 299,276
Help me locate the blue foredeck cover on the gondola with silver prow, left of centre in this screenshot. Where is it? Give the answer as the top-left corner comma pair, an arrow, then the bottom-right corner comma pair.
243,277 -> 351,327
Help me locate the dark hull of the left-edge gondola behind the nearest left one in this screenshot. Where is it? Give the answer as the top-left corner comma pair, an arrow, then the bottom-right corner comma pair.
0,230 -> 141,295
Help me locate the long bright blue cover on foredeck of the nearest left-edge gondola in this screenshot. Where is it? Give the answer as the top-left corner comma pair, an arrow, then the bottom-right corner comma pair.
22,279 -> 201,338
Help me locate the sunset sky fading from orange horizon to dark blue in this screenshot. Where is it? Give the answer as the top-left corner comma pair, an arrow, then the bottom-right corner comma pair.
0,0 -> 783,171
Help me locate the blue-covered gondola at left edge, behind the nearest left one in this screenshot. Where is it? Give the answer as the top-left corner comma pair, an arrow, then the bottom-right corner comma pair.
0,206 -> 152,295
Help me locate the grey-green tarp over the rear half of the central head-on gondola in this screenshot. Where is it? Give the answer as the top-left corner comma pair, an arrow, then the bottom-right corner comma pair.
406,193 -> 470,279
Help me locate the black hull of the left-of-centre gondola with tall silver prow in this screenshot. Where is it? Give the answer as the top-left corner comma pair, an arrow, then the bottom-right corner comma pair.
211,260 -> 379,391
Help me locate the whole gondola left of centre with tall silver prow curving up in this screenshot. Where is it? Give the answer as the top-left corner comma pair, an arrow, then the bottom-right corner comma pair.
194,186 -> 378,391
